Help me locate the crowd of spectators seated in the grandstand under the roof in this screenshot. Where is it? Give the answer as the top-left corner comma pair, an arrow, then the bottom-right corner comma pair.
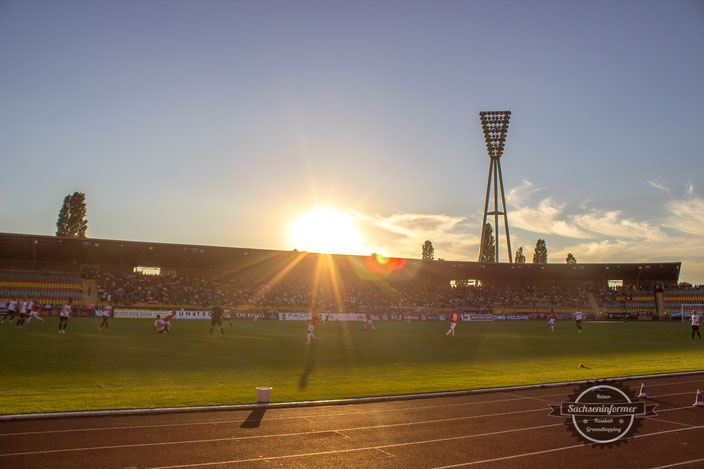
97,273 -> 589,311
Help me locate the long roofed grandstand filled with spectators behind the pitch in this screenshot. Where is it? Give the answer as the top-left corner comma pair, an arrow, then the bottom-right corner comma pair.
0,233 -> 692,318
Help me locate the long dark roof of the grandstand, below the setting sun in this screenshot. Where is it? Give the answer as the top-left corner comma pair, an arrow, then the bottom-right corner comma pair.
0,233 -> 681,285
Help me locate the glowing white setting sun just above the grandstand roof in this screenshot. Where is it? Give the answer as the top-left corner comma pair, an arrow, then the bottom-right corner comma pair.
290,207 -> 364,254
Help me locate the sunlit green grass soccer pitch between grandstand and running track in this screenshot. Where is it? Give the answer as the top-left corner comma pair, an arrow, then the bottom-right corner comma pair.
0,318 -> 704,414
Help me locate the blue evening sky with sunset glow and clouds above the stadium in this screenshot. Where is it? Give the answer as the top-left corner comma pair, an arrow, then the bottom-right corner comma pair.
0,0 -> 704,284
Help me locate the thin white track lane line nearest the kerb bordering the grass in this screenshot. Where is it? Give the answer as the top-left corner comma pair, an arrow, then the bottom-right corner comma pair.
0,381 -> 699,436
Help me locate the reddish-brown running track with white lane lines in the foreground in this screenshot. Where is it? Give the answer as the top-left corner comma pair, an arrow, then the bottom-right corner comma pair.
0,373 -> 704,469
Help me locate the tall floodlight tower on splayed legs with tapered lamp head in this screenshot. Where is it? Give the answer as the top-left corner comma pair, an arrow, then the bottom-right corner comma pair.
479,111 -> 513,263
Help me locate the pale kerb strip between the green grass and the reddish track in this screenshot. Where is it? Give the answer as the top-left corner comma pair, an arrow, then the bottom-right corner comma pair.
0,370 -> 704,422
